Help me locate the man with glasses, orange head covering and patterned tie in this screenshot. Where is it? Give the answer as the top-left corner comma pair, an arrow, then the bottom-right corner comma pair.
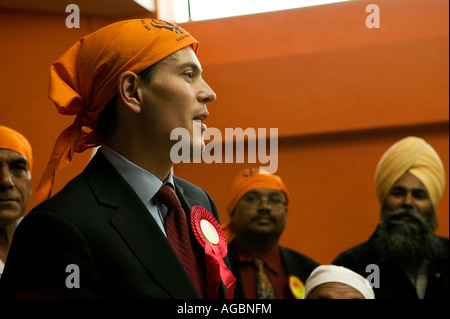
224,168 -> 318,299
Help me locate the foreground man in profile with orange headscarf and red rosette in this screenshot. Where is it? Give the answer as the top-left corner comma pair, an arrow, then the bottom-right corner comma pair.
0,19 -> 234,298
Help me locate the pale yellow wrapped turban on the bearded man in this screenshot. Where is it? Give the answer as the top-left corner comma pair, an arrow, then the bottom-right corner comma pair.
375,136 -> 445,208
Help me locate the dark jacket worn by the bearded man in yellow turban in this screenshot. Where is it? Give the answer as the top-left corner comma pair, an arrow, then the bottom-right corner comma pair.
333,233 -> 450,299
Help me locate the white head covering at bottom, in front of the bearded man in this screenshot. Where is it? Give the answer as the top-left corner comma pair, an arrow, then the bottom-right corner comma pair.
305,265 -> 375,299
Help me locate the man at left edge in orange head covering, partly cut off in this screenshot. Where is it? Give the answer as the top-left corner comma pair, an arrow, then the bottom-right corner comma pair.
0,125 -> 33,277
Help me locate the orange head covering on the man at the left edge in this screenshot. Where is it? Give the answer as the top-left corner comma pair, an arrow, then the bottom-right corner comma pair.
0,125 -> 33,173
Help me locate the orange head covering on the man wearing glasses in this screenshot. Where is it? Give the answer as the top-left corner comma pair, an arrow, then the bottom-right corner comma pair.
223,168 -> 289,242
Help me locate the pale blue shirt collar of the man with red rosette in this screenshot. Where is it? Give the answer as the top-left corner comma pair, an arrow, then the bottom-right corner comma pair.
100,143 -> 174,234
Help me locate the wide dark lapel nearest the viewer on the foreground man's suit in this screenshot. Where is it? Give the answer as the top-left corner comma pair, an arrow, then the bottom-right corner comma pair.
85,152 -> 198,299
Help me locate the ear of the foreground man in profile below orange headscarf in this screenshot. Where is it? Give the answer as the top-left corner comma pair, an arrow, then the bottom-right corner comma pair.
118,71 -> 142,114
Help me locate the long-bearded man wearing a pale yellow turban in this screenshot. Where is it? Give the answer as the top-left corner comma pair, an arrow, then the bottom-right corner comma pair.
333,136 -> 450,299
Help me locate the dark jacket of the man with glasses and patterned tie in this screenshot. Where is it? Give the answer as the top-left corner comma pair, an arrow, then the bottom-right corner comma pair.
228,241 -> 319,298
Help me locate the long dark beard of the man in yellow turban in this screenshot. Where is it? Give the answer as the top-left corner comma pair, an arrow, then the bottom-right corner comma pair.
373,208 -> 444,274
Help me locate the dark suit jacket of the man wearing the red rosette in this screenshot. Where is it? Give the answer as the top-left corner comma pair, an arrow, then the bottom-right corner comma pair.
0,152 -> 228,299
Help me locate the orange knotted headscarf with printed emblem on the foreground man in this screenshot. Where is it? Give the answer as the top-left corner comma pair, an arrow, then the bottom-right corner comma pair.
37,19 -> 198,198
